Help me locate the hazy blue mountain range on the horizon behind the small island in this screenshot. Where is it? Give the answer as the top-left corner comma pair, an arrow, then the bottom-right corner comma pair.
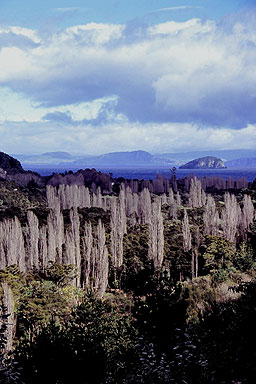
12,149 -> 256,169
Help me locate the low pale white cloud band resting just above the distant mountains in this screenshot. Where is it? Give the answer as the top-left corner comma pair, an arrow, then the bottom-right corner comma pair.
0,122 -> 256,155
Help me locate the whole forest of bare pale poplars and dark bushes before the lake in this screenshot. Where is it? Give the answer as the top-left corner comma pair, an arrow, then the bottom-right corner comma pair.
0,169 -> 256,384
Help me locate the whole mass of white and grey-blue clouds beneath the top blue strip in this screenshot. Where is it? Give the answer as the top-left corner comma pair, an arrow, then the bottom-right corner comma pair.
0,14 -> 256,153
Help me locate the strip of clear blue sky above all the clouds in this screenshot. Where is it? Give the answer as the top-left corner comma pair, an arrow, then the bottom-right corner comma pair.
0,0 -> 253,28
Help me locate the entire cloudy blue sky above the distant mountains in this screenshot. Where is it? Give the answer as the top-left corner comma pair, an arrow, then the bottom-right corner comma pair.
0,0 -> 256,155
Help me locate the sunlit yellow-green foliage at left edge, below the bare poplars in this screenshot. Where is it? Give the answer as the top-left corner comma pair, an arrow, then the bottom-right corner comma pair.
0,263 -> 82,339
